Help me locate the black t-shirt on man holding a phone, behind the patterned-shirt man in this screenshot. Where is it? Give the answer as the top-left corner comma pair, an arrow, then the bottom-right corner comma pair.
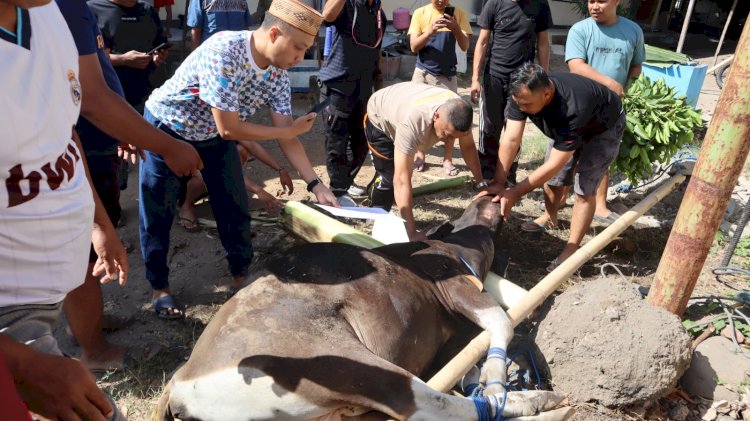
88,0 -> 166,105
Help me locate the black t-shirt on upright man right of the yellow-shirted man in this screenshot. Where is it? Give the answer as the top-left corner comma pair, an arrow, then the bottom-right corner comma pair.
477,0 -> 552,77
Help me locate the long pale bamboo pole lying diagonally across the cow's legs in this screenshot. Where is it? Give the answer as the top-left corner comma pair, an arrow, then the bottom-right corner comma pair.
427,174 -> 685,392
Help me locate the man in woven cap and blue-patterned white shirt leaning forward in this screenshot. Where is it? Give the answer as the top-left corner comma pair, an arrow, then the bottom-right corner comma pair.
139,0 -> 337,319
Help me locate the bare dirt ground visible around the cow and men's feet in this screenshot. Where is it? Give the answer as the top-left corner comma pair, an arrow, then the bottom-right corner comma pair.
57,60 -> 746,420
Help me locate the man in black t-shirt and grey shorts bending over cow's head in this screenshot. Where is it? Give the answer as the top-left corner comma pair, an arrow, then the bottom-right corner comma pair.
485,63 -> 625,271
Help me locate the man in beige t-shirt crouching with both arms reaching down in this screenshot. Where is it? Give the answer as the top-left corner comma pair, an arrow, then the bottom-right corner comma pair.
364,82 -> 488,241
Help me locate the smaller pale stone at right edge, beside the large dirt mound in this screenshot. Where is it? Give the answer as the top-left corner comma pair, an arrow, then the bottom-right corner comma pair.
680,336 -> 750,402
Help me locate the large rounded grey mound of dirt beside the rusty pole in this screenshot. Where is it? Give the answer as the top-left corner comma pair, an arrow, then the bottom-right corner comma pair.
535,278 -> 691,407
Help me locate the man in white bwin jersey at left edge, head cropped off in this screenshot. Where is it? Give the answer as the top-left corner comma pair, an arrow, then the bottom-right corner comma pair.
0,0 -> 127,420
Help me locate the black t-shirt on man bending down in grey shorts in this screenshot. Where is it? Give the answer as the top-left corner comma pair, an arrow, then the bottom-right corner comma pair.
505,73 -> 622,152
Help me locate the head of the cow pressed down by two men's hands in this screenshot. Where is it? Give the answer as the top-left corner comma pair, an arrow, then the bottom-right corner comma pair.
427,196 -> 502,277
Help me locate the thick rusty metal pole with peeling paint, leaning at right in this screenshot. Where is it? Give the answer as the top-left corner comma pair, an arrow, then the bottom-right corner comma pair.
648,19 -> 750,316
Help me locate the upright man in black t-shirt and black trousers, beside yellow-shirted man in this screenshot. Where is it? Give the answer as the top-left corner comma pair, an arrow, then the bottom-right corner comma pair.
471,0 -> 552,181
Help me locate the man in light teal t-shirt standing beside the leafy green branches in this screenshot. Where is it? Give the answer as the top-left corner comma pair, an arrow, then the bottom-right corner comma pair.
523,0 -> 646,236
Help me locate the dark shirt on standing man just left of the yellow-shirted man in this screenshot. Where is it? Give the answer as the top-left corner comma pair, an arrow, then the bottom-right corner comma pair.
318,0 -> 386,84
